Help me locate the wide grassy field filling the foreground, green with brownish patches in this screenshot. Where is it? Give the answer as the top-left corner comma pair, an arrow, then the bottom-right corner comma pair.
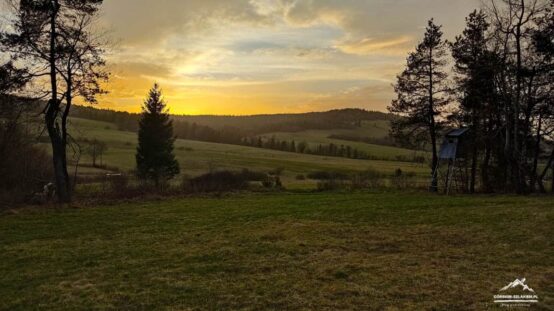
0,193 -> 554,310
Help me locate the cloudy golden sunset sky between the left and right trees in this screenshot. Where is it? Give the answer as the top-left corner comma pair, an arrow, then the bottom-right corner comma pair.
94,0 -> 480,115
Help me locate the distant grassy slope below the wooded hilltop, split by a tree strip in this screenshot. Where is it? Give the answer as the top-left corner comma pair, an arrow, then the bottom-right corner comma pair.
262,121 -> 421,159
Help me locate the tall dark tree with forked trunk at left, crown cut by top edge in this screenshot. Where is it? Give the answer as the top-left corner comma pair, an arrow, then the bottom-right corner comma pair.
0,0 -> 108,203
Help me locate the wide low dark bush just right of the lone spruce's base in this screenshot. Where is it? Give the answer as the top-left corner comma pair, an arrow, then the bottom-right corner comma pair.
183,171 -> 248,193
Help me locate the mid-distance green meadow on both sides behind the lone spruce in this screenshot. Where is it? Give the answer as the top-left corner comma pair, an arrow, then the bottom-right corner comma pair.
67,118 -> 429,187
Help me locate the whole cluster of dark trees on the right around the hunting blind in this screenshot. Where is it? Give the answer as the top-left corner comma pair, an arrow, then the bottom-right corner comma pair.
389,0 -> 554,193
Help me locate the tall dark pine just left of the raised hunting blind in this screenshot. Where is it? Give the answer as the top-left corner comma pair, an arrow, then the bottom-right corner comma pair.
388,19 -> 448,192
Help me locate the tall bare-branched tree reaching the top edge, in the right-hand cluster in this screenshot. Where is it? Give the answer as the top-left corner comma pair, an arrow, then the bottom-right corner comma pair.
487,0 -> 550,193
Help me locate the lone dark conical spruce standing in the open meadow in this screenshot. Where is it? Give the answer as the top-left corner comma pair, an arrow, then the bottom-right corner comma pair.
136,84 -> 179,186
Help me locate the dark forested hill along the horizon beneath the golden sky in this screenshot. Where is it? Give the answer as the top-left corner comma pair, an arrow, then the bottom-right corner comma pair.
72,106 -> 391,136
